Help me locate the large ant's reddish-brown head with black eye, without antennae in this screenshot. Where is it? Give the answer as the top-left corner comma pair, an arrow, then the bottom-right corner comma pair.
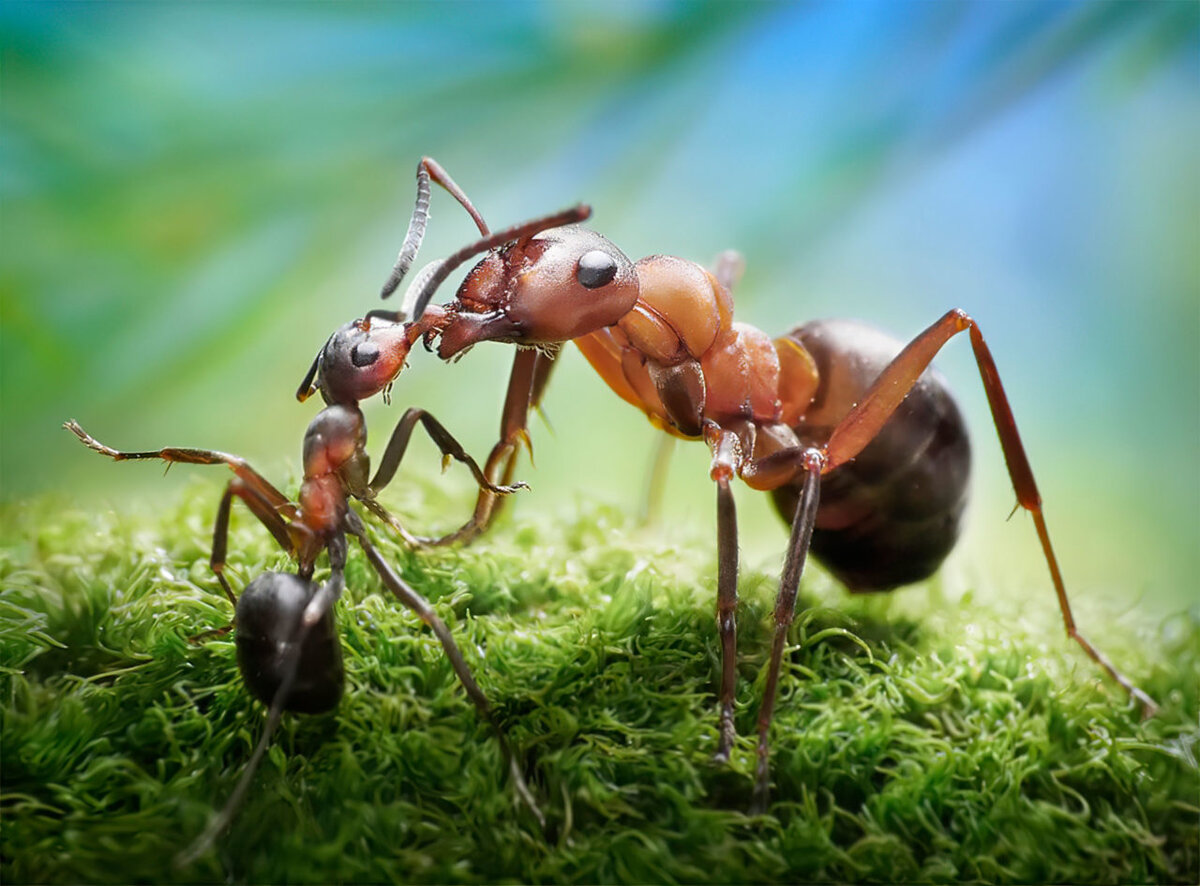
438,226 -> 638,359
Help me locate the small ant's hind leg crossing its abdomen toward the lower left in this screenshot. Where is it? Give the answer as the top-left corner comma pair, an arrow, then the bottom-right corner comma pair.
174,533 -> 347,868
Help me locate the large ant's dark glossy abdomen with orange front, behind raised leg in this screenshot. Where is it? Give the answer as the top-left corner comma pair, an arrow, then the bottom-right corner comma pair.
773,321 -> 971,591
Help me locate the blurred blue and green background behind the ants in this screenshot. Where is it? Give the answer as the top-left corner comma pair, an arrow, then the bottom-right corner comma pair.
0,1 -> 1200,611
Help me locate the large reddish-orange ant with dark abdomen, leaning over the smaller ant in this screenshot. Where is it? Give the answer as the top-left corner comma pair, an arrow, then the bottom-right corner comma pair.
357,158 -> 1157,812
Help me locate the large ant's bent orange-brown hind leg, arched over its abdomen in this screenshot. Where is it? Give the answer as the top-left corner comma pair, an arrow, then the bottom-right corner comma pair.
823,309 -> 1158,717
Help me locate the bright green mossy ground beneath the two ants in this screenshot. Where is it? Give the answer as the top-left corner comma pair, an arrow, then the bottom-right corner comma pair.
0,475 -> 1200,884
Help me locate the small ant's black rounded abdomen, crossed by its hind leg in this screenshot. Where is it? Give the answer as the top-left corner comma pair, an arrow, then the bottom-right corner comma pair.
234,573 -> 346,713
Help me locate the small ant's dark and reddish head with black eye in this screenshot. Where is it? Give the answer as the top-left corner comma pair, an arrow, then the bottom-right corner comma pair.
296,318 -> 413,405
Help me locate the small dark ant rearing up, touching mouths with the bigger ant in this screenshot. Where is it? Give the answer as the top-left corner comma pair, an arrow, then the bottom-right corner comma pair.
64,304 -> 545,864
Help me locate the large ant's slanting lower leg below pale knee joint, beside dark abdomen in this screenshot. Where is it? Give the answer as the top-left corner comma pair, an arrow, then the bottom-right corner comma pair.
750,449 -> 824,815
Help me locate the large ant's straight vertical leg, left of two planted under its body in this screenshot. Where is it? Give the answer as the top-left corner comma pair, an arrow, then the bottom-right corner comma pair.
704,424 -> 740,762
